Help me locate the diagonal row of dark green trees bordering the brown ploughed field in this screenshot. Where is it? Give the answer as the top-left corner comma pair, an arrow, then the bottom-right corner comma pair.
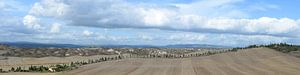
0,48 -> 248,73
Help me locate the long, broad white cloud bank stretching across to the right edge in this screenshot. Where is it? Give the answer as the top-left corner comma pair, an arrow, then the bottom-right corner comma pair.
27,0 -> 300,37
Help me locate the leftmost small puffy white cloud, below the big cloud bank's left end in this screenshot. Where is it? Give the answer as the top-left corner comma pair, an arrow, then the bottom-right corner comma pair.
23,15 -> 42,30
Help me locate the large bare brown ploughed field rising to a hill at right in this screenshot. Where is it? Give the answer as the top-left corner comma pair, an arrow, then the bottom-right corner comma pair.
3,48 -> 300,75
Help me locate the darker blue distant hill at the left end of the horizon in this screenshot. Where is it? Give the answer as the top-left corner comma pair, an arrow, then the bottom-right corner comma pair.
0,42 -> 85,48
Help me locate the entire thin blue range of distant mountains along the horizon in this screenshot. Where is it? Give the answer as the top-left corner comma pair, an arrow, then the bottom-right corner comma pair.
0,42 -> 232,48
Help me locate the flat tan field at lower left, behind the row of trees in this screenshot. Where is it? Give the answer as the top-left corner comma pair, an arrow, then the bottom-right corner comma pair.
0,55 -> 116,70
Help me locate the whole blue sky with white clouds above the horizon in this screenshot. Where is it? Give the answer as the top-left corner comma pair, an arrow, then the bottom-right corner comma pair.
0,0 -> 300,46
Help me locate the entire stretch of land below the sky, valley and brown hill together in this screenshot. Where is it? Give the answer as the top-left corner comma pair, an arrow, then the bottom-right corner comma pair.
0,44 -> 300,75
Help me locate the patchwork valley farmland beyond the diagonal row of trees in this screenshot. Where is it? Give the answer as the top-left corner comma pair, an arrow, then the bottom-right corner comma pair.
0,46 -> 229,72
